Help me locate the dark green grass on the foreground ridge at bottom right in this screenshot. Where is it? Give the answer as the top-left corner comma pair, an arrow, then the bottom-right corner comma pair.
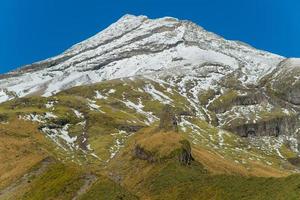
141,162 -> 300,200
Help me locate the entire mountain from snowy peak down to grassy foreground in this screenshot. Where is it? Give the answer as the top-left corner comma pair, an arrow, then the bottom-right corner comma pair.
0,15 -> 300,199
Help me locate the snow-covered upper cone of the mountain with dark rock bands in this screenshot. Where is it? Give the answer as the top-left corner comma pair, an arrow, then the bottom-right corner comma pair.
0,15 -> 284,102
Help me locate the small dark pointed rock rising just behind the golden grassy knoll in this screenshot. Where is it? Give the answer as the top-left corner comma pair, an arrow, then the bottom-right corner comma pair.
159,105 -> 178,132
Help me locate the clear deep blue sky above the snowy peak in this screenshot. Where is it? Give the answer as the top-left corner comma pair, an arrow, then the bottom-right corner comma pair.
0,0 -> 300,73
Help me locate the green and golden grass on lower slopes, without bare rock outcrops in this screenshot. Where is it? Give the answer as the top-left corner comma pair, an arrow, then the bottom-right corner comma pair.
0,79 -> 300,199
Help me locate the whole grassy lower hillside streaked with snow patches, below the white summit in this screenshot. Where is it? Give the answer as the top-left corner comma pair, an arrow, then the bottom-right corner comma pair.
0,78 -> 300,199
